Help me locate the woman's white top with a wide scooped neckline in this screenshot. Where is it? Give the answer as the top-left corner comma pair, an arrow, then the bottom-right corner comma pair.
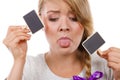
22,53 -> 113,80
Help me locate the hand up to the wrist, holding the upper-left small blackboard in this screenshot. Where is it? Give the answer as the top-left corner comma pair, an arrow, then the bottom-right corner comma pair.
3,26 -> 31,61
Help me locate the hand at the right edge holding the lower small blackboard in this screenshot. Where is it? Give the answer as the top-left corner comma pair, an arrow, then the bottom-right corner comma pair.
98,47 -> 120,80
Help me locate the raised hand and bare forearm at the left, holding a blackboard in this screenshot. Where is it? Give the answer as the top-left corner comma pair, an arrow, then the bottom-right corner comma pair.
3,26 -> 30,80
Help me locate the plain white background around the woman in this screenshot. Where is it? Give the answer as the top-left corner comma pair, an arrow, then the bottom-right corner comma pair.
0,0 -> 120,80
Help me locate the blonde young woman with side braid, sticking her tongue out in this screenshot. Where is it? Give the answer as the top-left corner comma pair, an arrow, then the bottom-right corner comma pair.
3,0 -> 120,80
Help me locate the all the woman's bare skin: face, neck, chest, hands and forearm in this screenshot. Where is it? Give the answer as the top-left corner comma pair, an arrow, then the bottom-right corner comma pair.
3,0 -> 120,80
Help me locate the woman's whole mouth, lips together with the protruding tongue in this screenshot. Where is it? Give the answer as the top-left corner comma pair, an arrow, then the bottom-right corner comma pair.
58,37 -> 71,48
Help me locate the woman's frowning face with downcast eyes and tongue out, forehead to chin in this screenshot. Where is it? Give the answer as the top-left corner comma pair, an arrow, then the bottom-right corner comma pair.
41,0 -> 84,54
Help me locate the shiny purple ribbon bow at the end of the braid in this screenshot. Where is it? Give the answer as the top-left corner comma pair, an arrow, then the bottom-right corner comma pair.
73,71 -> 103,80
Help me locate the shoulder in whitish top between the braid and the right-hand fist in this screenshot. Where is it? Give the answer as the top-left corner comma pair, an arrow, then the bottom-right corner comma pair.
91,53 -> 113,80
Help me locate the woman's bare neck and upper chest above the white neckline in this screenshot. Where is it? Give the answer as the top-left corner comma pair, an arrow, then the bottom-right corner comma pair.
46,52 -> 82,77
